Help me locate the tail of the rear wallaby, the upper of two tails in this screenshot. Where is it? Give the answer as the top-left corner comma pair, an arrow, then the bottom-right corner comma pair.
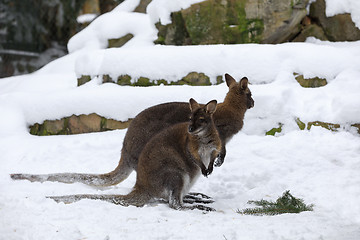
10,157 -> 133,187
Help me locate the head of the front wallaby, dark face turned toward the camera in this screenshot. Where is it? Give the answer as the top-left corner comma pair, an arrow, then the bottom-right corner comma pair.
188,98 -> 217,135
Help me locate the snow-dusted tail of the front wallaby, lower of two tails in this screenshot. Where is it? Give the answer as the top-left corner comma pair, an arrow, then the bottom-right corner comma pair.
47,189 -> 151,207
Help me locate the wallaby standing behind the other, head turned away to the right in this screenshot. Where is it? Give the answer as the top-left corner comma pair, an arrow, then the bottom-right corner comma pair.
11,74 -> 254,186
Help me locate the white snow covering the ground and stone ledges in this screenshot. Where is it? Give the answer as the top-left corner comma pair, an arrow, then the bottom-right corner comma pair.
0,0 -> 360,240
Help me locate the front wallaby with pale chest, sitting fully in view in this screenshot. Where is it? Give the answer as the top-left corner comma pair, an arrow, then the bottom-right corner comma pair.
50,99 -> 221,210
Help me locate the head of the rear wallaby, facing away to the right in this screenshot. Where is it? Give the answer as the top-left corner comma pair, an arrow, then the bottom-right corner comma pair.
225,73 -> 254,109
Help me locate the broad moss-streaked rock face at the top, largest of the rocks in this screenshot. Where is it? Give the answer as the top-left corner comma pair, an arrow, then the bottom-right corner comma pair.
157,0 -> 309,45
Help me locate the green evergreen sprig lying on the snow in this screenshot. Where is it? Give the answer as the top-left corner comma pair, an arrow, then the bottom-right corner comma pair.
236,190 -> 314,215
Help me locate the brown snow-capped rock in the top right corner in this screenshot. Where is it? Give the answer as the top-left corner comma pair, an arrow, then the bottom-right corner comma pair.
309,0 -> 360,41
